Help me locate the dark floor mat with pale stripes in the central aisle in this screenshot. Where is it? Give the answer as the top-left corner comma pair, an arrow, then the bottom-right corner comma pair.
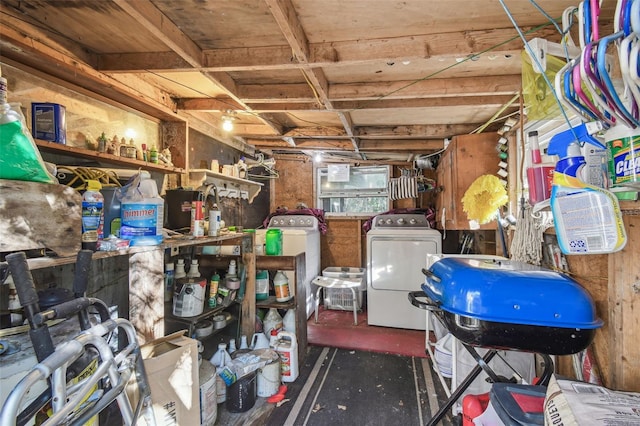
268,347 -> 460,426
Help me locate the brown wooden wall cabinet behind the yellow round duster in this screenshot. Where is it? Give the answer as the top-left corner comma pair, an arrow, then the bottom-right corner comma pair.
436,133 -> 500,229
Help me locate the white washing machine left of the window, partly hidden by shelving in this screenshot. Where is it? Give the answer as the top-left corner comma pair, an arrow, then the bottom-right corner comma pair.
256,215 -> 322,318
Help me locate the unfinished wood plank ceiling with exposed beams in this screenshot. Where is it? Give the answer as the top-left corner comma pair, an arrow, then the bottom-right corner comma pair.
0,0 -> 614,163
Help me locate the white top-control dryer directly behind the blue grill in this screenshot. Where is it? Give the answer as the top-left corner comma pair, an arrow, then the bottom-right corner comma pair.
367,213 -> 442,330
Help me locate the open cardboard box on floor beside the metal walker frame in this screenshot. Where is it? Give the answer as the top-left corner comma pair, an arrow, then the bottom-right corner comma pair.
140,330 -> 200,426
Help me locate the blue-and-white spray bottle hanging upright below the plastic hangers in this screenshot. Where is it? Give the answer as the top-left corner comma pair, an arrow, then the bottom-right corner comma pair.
547,122 -> 627,254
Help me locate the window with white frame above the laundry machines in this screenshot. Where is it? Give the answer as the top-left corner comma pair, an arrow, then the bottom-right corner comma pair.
316,165 -> 390,215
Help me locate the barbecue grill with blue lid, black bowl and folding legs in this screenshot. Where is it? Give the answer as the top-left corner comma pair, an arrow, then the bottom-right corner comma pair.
409,257 -> 603,425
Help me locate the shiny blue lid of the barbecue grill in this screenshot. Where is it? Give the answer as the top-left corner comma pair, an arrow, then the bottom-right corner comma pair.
422,257 -> 602,329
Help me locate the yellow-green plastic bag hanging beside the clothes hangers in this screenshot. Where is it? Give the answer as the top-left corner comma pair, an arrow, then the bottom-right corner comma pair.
521,51 -> 566,120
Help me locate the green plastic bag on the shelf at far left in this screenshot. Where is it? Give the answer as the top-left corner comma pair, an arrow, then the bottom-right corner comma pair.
0,104 -> 58,183
